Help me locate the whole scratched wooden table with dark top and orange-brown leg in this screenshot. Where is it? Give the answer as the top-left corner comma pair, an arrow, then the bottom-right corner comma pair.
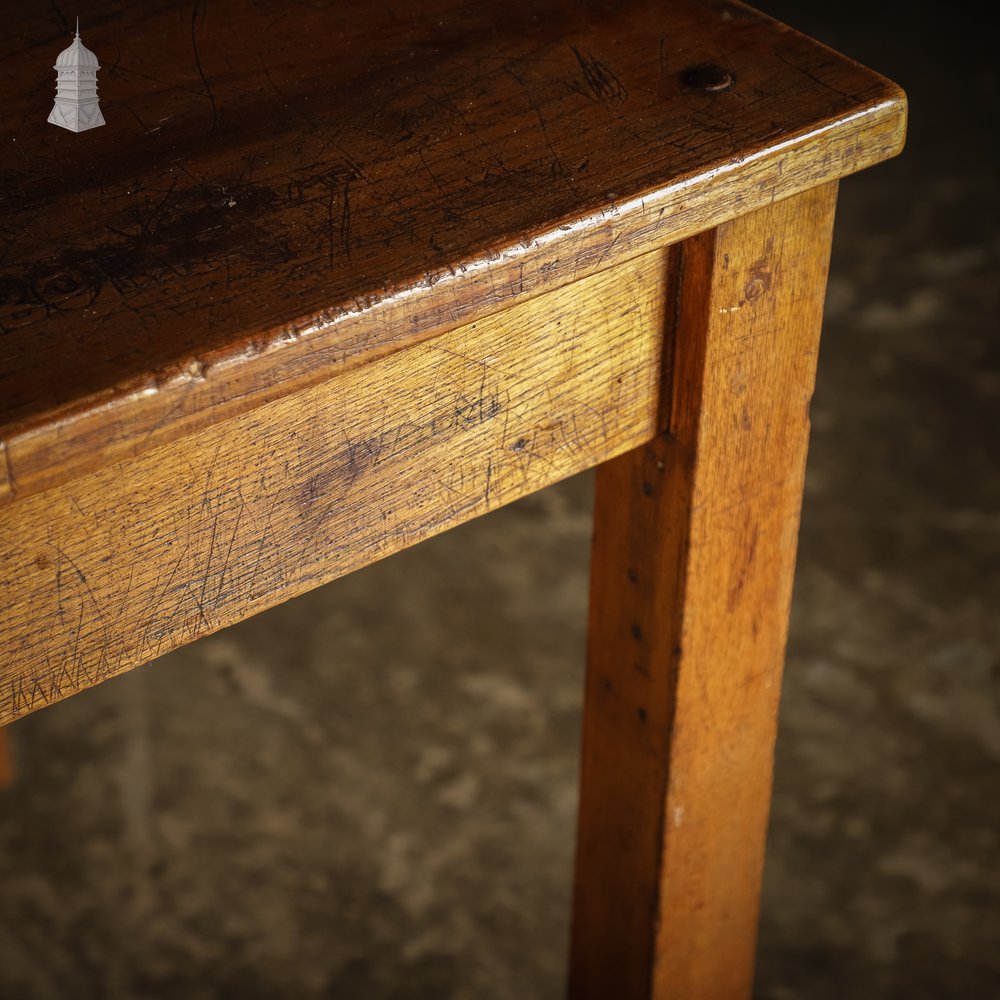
0,0 -> 905,998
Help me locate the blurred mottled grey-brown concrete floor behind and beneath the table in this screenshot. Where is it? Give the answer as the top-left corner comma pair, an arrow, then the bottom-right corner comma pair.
0,0 -> 1000,1000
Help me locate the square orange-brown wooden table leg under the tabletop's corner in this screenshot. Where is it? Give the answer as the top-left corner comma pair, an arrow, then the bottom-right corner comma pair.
569,184 -> 836,1000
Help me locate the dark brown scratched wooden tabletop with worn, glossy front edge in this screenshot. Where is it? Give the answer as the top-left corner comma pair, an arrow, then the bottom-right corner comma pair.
0,0 -> 904,503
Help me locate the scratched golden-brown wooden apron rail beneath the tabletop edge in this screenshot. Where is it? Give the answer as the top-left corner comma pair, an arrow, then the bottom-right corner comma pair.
0,246 -> 666,724
